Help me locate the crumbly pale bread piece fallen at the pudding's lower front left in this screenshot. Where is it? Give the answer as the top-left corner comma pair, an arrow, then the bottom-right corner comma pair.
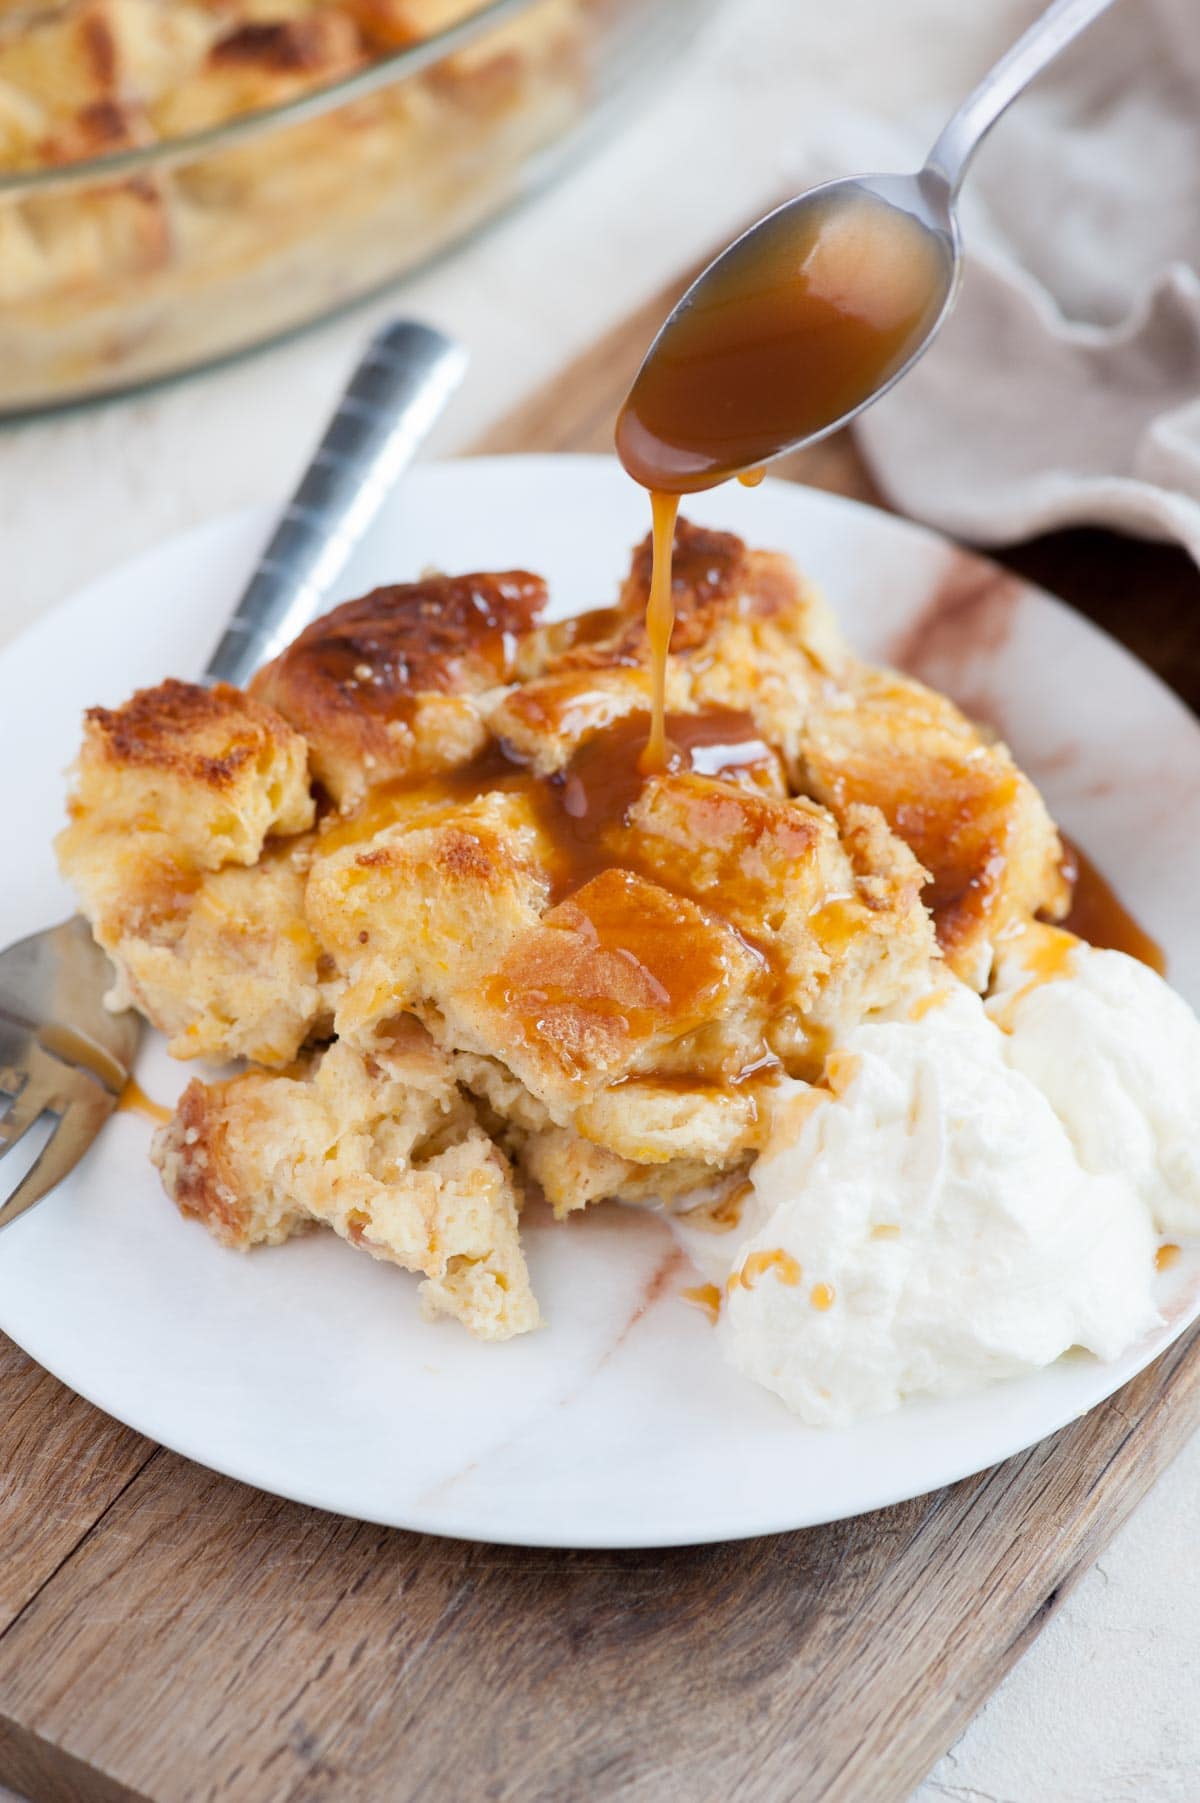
153,1022 -> 539,1340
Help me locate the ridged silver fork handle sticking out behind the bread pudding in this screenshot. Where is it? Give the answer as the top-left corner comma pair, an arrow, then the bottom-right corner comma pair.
204,319 -> 467,685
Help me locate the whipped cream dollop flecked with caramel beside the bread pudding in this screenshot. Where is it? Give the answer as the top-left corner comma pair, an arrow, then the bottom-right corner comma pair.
676,929 -> 1200,1426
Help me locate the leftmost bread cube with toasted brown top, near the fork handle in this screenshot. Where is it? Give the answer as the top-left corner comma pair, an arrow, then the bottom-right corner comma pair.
59,680 -> 314,874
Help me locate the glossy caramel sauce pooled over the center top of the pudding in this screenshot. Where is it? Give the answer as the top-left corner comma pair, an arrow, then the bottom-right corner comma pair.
327,707 -> 800,1093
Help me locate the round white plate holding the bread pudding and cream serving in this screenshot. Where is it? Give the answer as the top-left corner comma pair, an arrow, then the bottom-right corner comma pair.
0,458 -> 1200,1547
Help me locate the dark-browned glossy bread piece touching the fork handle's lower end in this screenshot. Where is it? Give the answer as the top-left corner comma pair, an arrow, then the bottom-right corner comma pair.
250,570 -> 546,808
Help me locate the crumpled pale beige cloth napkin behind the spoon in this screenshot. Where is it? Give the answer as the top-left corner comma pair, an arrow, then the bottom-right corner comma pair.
818,0 -> 1200,563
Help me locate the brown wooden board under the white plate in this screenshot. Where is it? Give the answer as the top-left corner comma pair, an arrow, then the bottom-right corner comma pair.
0,257 -> 1200,1803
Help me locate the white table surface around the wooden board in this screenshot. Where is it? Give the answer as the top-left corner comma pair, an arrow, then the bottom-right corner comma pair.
0,0 -> 1200,1803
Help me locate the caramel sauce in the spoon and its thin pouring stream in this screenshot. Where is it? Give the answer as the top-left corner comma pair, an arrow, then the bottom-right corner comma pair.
616,191 -> 948,796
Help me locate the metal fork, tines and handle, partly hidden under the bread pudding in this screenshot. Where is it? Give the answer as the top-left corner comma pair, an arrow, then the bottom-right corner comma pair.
0,319 -> 467,1228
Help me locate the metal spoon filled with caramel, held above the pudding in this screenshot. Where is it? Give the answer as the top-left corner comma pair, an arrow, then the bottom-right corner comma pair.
616,0 -> 1114,494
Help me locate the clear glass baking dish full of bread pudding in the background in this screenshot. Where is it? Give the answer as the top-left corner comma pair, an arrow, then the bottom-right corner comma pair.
0,0 -> 715,415
